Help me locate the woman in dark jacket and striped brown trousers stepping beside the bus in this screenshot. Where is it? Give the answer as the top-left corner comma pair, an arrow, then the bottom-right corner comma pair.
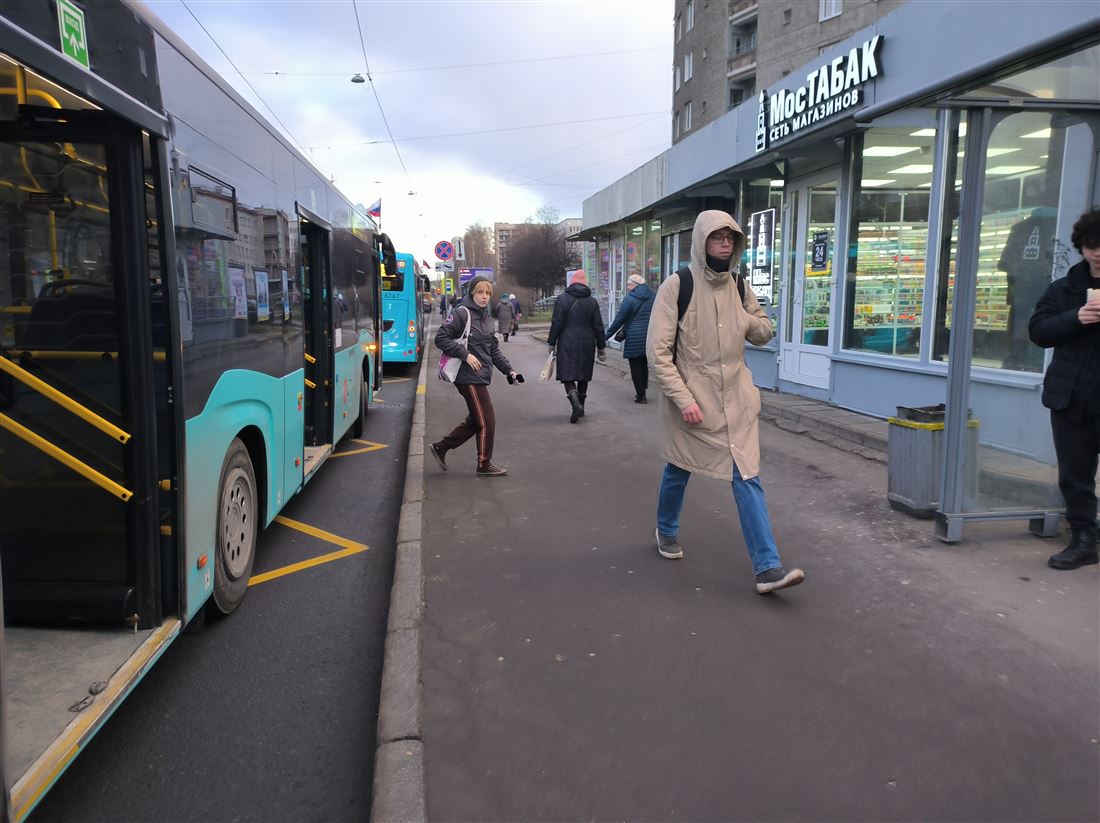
429,276 -> 521,478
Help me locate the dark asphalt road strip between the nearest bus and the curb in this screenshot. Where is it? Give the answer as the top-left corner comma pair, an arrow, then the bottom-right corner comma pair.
31,366 -> 416,823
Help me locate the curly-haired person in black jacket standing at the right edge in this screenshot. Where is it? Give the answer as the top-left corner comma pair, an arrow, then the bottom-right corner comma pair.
1027,210 -> 1100,569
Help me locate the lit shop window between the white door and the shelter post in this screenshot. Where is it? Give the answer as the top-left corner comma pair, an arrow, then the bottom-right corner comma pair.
844,125 -> 935,358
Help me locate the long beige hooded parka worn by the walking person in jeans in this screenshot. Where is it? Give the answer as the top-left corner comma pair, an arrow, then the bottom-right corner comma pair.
646,211 -> 773,481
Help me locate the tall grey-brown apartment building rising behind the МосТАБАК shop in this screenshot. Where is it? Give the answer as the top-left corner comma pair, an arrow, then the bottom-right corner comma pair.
672,0 -> 905,143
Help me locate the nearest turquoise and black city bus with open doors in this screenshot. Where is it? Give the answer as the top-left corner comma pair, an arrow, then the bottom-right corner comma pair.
0,0 -> 397,820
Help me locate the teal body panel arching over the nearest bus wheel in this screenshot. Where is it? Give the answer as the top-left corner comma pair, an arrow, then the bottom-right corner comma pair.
184,370 -> 305,618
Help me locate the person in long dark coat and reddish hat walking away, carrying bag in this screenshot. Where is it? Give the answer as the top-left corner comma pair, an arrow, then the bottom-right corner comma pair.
547,268 -> 607,423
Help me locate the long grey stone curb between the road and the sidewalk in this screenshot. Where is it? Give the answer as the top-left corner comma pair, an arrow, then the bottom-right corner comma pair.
371,354 -> 428,823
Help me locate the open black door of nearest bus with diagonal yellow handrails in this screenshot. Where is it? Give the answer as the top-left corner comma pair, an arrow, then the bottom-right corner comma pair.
0,111 -> 166,629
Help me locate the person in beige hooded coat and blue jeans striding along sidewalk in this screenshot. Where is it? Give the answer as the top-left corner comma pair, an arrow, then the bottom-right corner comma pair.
646,211 -> 805,594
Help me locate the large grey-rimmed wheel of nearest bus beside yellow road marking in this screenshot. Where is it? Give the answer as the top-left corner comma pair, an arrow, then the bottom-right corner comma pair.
213,438 -> 260,614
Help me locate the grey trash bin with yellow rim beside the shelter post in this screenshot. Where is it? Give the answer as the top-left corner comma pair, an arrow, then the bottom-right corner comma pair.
887,403 -> 979,519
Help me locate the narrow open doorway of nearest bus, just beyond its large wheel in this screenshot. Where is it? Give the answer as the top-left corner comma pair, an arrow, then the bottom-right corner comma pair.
299,215 -> 334,468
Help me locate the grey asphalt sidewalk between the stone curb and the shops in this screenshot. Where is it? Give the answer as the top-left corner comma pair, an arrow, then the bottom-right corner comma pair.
376,329 -> 1100,821
